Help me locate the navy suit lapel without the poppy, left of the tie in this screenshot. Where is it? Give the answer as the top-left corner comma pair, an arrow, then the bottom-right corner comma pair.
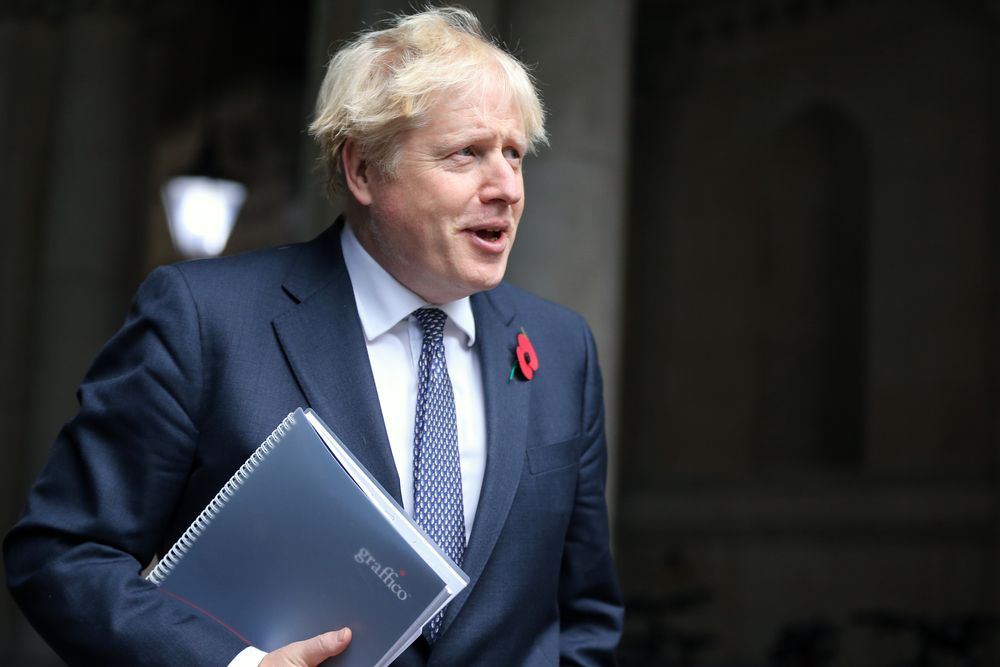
273,224 -> 402,505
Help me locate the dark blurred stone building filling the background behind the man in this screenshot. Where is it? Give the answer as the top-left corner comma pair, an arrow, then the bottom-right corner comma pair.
0,0 -> 1000,667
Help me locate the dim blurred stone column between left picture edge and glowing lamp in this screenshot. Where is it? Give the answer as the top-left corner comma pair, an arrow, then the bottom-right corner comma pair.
30,1 -> 148,464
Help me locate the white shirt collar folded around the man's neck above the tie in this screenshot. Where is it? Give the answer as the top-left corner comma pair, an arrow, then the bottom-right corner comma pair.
340,223 -> 476,347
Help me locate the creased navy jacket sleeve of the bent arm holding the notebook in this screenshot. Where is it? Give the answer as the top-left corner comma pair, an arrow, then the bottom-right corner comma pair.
4,267 -> 246,667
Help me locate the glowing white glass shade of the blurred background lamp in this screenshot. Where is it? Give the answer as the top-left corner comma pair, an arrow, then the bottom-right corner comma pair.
160,176 -> 247,257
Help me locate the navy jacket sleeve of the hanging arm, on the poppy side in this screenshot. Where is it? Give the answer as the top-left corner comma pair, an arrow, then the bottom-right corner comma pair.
559,325 -> 624,666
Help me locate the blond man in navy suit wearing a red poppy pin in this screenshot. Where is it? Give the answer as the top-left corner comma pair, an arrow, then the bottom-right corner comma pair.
5,9 -> 622,667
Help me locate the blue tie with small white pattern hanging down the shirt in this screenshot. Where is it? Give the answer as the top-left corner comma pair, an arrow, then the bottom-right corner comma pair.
413,308 -> 465,642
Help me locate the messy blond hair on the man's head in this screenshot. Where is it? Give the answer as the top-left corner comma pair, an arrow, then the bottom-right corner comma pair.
309,7 -> 547,191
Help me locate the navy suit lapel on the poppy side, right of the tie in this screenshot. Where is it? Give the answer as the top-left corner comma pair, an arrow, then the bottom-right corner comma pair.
438,290 -> 531,642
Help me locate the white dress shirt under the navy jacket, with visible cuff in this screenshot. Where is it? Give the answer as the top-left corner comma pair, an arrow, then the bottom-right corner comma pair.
229,224 -> 486,667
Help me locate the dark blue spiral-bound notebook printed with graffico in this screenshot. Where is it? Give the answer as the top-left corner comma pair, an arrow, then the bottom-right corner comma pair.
147,408 -> 469,667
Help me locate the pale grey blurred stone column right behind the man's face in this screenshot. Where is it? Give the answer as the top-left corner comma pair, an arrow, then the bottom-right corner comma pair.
498,0 -> 632,520
